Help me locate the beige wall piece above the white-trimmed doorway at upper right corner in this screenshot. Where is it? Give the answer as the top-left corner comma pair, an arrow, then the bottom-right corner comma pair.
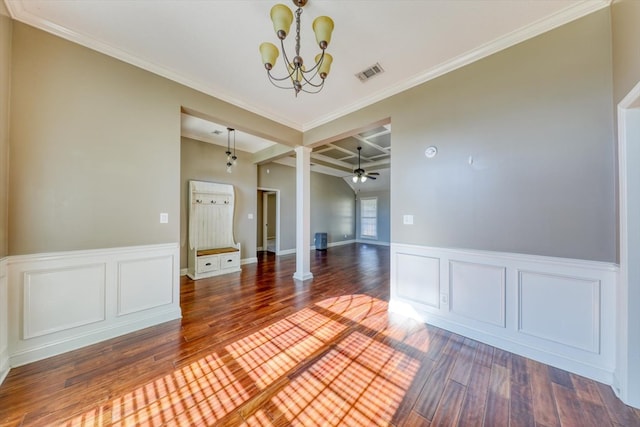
611,0 -> 640,105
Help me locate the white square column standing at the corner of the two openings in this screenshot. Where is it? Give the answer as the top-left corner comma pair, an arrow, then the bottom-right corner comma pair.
293,147 -> 313,280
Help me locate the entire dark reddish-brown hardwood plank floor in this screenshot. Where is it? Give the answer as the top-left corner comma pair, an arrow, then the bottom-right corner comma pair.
0,244 -> 640,427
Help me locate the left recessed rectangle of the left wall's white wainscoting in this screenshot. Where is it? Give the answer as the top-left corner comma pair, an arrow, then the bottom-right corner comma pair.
23,264 -> 106,339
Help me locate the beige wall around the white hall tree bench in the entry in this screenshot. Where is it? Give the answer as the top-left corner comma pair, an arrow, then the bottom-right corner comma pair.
180,137 -> 258,268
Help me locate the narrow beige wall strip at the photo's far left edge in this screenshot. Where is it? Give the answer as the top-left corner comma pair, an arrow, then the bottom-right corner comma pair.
0,6 -> 12,258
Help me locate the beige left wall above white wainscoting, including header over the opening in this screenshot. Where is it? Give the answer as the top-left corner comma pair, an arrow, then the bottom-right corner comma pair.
9,23 -> 302,255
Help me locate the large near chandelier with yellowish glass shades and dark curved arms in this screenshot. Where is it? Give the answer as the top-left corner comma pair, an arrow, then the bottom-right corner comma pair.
260,0 -> 333,97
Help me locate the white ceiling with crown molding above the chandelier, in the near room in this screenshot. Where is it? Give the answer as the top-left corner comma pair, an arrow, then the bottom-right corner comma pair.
5,0 -> 609,131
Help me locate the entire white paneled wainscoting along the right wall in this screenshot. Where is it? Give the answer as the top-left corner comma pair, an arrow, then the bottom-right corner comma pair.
389,243 -> 618,384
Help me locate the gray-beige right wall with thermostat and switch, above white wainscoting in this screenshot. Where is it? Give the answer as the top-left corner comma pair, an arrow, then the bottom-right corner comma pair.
305,9 -> 616,262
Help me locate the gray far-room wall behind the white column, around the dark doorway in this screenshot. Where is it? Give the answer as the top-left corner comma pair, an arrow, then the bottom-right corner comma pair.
258,163 -> 355,250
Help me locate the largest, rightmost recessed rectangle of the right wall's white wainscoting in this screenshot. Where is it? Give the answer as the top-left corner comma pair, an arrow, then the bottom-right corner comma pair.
518,271 -> 600,353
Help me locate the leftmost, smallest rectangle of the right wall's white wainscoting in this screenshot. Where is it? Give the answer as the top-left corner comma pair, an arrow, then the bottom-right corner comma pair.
395,252 -> 440,308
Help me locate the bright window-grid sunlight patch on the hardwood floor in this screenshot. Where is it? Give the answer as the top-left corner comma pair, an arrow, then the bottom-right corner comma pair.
64,295 -> 430,426
